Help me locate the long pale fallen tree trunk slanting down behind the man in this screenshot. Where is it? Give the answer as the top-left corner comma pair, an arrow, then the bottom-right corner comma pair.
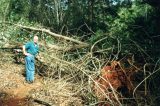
14,24 -> 88,47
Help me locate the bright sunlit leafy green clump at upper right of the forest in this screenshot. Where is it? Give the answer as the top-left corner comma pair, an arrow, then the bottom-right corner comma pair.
109,5 -> 152,40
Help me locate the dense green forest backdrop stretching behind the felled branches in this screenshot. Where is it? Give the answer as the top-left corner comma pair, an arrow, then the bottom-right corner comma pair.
0,0 -> 158,58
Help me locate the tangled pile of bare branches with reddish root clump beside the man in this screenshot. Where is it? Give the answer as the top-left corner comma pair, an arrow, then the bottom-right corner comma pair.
0,23 -> 158,106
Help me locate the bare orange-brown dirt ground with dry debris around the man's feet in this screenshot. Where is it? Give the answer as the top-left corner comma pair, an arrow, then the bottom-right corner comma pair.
0,53 -> 82,106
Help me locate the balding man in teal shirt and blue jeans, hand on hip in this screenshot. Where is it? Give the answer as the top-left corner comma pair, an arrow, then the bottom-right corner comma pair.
23,36 -> 39,83
